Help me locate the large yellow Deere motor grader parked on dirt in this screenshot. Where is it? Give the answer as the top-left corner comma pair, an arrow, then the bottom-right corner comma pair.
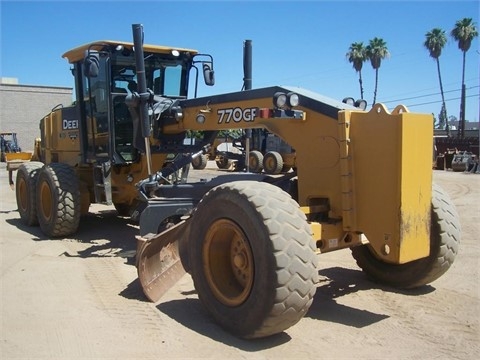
15,24 -> 461,338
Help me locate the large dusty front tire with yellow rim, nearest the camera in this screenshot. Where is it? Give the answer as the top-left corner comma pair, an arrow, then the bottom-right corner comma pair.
189,181 -> 318,338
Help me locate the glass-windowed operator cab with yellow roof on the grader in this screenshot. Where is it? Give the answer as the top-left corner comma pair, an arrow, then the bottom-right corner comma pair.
63,41 -> 211,165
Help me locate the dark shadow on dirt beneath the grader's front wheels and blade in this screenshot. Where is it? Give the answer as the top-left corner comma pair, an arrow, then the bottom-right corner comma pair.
119,267 -> 435,346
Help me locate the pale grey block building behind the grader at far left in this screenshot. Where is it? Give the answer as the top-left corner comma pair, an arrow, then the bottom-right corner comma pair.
0,78 -> 73,151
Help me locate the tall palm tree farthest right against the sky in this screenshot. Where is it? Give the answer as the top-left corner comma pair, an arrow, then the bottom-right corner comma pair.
450,18 -> 478,139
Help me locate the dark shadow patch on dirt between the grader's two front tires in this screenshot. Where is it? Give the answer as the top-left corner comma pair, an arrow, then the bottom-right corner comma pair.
306,267 -> 435,328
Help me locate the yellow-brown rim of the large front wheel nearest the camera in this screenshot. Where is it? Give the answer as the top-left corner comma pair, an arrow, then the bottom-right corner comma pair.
202,219 -> 254,306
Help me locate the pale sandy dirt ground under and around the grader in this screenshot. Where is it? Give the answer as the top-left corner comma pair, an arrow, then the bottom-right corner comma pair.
0,164 -> 480,359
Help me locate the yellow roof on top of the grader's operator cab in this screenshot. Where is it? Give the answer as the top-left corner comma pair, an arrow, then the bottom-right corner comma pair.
62,40 -> 198,64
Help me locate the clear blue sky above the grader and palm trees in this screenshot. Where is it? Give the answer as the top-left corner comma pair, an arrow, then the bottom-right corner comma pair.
0,0 -> 480,121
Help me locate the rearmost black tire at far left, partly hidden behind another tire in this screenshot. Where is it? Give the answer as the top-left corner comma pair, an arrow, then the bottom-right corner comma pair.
15,161 -> 43,226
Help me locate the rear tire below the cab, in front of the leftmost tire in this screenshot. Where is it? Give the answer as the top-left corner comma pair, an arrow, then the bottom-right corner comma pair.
36,163 -> 81,237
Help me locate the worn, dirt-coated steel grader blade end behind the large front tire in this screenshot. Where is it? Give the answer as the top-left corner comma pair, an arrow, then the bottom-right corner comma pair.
137,221 -> 188,302
